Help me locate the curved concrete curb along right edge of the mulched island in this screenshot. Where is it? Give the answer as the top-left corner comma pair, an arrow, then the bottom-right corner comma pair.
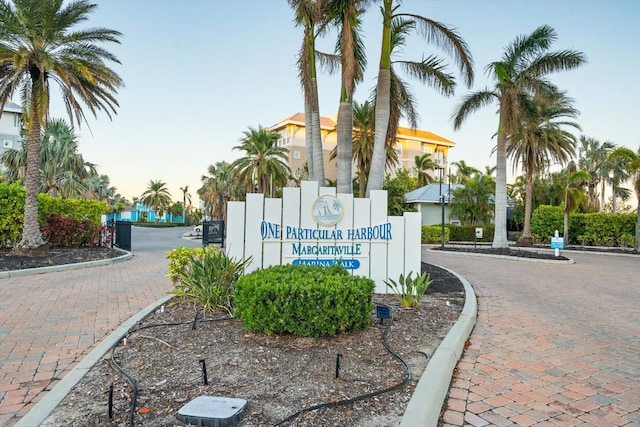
400,266 -> 478,427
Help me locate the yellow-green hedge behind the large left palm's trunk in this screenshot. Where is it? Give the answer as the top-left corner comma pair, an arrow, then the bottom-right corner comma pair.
0,183 -> 109,248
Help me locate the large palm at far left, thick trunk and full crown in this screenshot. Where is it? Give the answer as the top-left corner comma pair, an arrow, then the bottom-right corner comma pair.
0,0 -> 122,255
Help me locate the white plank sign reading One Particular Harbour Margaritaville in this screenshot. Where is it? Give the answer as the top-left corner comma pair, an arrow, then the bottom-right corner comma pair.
225,182 -> 421,293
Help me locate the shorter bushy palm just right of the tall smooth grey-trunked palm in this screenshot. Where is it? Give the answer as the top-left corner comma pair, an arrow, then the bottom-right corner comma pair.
507,93 -> 580,245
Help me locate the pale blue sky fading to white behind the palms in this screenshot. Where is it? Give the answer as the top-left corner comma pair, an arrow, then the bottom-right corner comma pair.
41,0 -> 640,204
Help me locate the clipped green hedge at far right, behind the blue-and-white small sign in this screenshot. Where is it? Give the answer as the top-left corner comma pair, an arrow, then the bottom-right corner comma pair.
531,205 -> 637,247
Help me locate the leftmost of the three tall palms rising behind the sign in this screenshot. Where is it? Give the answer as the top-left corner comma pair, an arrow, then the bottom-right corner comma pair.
288,0 -> 328,185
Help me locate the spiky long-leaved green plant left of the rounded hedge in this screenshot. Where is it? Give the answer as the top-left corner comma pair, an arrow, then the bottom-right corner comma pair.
169,247 -> 251,314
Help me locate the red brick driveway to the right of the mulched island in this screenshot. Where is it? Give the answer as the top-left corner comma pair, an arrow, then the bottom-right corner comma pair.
423,251 -> 640,426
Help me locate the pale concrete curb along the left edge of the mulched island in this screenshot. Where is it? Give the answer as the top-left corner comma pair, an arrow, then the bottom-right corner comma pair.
15,295 -> 173,427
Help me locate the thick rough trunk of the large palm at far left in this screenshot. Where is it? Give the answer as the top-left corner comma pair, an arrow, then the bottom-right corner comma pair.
14,90 -> 49,256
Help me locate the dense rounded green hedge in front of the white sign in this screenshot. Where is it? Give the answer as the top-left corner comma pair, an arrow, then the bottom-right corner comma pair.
234,265 -> 375,336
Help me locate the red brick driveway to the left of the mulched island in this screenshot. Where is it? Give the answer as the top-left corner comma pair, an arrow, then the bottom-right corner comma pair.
0,252 -> 171,426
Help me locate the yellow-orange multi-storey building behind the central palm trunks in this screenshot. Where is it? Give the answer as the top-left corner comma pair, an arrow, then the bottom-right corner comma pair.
269,113 -> 456,180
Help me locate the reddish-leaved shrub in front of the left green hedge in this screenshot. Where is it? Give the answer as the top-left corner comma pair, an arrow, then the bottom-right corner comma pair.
42,215 -> 100,248
